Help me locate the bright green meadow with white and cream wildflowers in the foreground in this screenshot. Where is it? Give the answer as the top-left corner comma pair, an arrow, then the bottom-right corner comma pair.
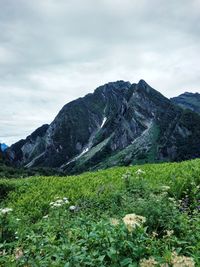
0,160 -> 200,267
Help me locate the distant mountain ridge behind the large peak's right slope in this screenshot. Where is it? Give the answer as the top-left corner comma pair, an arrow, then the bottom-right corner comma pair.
171,92 -> 200,114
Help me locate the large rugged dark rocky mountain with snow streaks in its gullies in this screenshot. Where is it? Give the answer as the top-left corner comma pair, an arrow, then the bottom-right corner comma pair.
6,80 -> 200,173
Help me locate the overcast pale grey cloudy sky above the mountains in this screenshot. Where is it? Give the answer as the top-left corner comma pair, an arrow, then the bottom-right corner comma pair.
0,0 -> 200,145
